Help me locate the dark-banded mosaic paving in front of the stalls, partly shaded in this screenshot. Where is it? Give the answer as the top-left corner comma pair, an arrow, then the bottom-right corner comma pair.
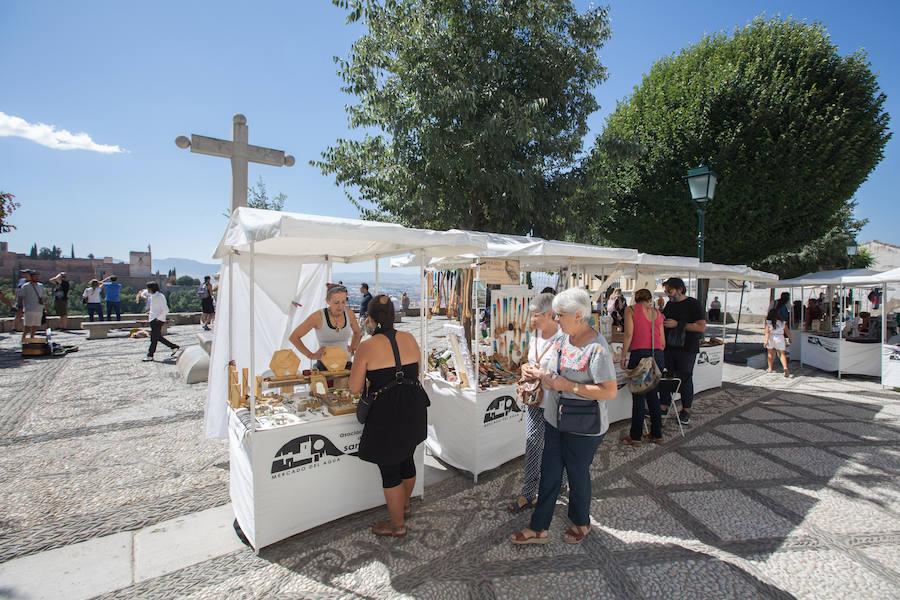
93,360 -> 900,599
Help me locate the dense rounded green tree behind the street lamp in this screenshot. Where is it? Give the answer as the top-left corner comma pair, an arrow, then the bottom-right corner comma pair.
577,18 -> 890,264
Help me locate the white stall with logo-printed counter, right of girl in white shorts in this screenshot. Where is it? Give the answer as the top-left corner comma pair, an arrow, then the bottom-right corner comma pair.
760,269 -> 882,378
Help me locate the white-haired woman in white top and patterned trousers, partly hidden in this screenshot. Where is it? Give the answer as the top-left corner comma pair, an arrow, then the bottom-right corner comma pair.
506,294 -> 560,513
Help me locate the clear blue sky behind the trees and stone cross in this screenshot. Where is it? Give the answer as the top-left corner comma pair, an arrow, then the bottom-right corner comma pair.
0,0 -> 900,262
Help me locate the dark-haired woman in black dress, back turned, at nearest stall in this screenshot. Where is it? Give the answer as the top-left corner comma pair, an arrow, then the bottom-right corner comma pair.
350,295 -> 427,537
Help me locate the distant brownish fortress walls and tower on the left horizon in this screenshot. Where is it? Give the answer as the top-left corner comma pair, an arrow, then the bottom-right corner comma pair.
0,242 -> 167,288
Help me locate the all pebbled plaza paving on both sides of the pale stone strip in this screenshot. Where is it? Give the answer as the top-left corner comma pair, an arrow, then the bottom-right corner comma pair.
0,327 -> 900,599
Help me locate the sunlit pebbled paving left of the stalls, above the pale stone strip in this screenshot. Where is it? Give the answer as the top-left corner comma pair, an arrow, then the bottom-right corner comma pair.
0,325 -> 228,562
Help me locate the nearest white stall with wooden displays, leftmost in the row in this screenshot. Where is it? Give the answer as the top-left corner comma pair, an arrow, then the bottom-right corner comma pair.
205,207 -> 486,550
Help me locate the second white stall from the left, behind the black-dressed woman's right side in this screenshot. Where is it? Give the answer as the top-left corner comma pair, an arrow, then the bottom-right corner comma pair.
392,231 -> 637,482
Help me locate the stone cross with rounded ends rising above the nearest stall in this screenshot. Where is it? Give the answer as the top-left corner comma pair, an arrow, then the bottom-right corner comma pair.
175,114 -> 294,212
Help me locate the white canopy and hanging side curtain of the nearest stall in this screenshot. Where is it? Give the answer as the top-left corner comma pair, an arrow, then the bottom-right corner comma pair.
206,207 -> 481,437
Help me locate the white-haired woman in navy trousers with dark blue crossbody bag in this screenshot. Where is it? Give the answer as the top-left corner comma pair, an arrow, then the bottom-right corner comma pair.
510,288 -> 618,544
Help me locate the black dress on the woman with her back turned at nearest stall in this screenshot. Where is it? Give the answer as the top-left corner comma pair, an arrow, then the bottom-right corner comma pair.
358,330 -> 428,465
